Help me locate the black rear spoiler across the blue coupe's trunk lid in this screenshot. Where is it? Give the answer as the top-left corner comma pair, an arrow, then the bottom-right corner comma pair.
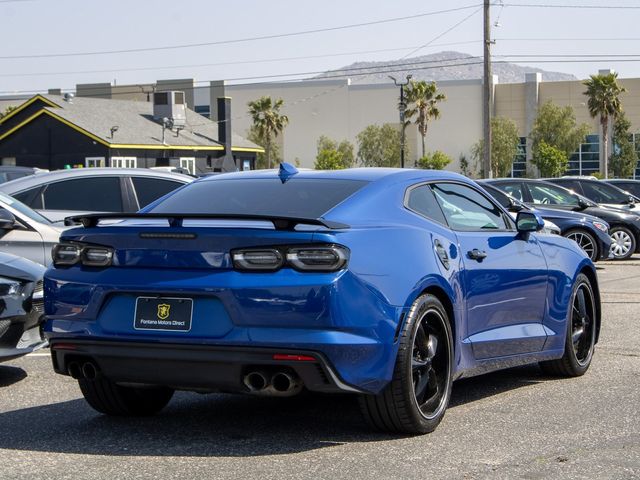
64,213 -> 349,230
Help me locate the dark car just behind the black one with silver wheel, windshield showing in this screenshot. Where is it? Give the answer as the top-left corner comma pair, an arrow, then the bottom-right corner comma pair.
547,177 -> 640,215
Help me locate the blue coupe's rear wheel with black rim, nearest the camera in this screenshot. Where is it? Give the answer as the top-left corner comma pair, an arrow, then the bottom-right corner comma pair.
359,295 -> 453,434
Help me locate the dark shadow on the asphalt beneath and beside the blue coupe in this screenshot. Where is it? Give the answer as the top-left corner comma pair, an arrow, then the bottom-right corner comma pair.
0,367 -> 543,457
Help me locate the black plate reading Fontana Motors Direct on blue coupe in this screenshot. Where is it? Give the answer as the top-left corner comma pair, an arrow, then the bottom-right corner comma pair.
133,297 -> 193,332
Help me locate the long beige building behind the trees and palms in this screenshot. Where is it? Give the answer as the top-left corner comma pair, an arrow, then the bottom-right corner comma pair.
41,71 -> 640,177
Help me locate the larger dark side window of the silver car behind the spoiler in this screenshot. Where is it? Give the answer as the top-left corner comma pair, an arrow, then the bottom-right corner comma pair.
43,177 -> 123,212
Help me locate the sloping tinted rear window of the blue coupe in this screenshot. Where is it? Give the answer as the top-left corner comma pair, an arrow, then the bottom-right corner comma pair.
151,178 -> 368,218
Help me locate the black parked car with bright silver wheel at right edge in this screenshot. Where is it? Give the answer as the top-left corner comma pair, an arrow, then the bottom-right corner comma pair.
487,178 -> 640,260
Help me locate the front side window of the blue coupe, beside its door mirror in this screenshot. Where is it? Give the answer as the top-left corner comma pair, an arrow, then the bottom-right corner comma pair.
432,183 -> 510,231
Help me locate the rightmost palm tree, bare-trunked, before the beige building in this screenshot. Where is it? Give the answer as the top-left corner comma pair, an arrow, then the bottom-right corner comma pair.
582,72 -> 627,178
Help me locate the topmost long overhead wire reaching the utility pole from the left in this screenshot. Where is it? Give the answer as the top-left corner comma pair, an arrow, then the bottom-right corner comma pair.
0,4 -> 478,60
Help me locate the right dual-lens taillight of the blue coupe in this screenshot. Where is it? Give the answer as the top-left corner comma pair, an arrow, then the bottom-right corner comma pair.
231,245 -> 349,272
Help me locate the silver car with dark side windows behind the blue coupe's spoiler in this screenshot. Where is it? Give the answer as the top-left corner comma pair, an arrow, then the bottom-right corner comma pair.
0,168 -> 193,222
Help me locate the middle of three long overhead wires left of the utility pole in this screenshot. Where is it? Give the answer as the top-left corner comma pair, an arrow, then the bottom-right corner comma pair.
0,40 -> 481,77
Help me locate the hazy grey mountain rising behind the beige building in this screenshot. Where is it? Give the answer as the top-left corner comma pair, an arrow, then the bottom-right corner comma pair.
315,52 -> 577,84
